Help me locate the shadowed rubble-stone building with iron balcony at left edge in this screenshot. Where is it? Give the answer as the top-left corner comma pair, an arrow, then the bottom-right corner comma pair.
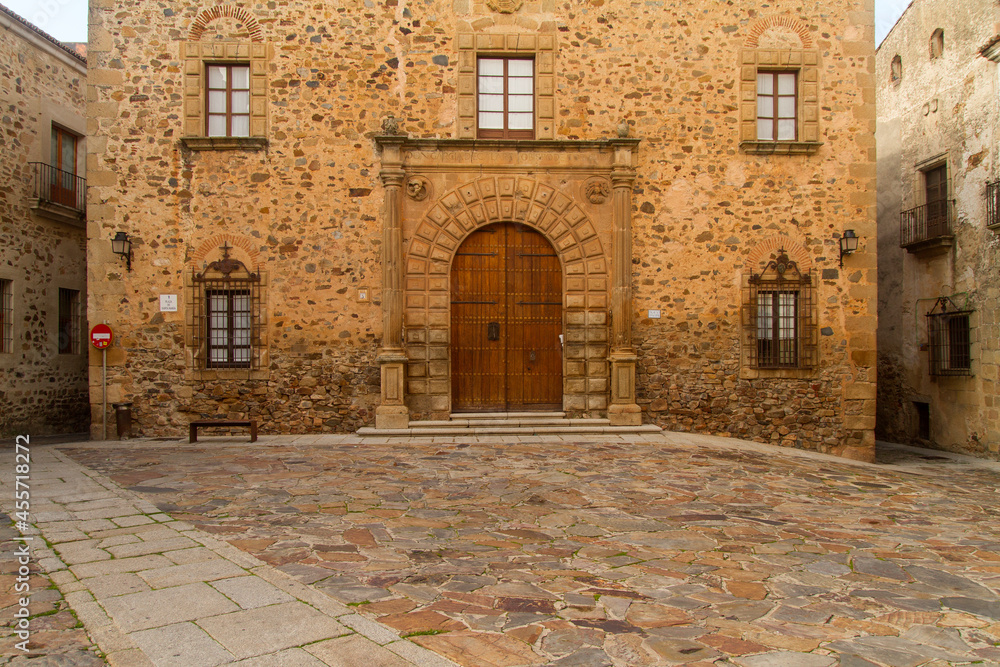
0,6 -> 90,435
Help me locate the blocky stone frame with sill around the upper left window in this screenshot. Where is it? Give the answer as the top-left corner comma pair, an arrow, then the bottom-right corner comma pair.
181,41 -> 272,151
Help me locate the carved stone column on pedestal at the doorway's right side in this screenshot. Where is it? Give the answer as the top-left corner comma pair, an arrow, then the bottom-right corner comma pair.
608,137 -> 642,426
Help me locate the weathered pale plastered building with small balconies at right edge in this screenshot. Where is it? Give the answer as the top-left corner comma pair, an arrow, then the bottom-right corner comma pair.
876,0 -> 1000,458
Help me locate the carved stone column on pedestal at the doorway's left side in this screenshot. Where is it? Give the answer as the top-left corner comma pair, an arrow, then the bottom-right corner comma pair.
375,130 -> 410,428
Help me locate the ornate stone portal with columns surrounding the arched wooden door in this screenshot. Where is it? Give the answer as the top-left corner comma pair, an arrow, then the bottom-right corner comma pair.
375,134 -> 641,428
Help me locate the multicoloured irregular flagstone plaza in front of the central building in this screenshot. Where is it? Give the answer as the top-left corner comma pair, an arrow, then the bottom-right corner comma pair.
52,433 -> 1000,667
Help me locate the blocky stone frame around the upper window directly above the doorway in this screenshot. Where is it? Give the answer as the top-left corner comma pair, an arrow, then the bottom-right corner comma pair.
456,33 -> 556,141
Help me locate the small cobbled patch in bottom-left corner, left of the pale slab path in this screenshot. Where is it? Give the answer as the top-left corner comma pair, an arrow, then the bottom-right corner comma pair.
0,513 -> 107,667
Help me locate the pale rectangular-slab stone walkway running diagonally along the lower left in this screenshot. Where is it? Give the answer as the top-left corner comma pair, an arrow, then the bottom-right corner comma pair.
0,447 -> 454,667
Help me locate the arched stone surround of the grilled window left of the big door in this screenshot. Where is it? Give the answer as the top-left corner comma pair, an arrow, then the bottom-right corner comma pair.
184,234 -> 270,381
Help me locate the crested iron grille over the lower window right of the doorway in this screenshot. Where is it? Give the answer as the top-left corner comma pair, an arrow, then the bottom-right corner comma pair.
744,249 -> 816,369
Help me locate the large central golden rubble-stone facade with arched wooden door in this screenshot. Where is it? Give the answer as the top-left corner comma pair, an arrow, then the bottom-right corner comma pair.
89,0 -> 876,458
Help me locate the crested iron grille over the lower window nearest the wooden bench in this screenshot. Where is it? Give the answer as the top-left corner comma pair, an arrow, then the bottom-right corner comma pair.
191,246 -> 261,369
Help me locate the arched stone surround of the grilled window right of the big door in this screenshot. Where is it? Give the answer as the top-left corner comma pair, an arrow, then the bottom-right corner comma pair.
740,245 -> 820,380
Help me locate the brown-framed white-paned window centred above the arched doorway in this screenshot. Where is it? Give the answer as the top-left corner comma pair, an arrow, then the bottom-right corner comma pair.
477,57 -> 535,139
